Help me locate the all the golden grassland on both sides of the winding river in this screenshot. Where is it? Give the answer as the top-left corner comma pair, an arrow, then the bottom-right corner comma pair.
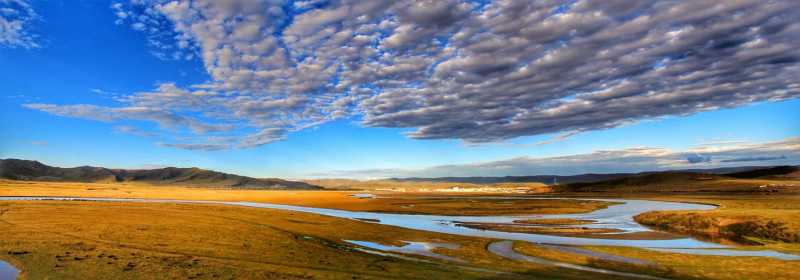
0,181 -> 800,279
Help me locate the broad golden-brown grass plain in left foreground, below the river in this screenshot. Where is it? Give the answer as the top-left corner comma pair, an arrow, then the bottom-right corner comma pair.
0,201 -> 636,279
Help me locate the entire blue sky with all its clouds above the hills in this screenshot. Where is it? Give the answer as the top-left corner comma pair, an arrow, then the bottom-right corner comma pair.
0,0 -> 800,178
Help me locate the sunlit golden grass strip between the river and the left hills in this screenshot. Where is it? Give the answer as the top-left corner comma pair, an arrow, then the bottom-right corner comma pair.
0,180 -> 608,215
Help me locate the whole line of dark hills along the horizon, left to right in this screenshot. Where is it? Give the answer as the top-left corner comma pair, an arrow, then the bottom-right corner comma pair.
0,159 -> 800,190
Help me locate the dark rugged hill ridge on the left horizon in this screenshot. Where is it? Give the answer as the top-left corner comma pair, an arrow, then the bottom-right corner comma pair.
0,159 -> 321,190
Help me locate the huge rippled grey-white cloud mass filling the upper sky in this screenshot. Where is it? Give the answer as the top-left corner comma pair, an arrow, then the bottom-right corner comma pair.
29,0 -> 800,147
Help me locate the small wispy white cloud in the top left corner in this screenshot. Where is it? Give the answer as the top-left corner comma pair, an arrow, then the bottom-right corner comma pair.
0,0 -> 40,49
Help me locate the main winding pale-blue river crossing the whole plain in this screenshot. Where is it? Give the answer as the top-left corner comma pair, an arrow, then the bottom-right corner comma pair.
0,197 -> 800,259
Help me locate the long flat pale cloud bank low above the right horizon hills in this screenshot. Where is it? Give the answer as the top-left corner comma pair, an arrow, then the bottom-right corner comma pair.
309,138 -> 800,178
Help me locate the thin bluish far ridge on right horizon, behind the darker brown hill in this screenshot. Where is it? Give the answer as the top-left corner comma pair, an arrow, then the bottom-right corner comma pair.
387,166 -> 792,184
